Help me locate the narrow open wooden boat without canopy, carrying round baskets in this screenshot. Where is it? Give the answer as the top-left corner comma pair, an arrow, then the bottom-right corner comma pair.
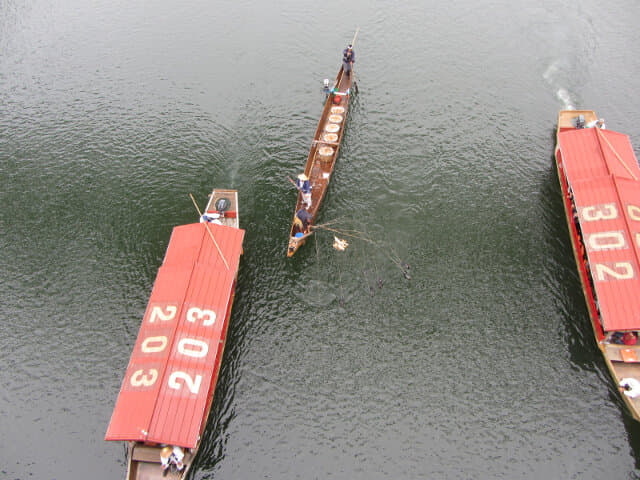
287,60 -> 354,257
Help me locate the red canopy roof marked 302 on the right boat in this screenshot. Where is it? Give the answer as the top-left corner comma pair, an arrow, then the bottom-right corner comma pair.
558,128 -> 640,331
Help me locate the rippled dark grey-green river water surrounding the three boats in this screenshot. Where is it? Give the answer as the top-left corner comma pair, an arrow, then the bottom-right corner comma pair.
0,0 -> 640,480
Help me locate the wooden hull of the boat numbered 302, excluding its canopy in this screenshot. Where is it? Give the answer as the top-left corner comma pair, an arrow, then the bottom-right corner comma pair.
555,110 -> 640,421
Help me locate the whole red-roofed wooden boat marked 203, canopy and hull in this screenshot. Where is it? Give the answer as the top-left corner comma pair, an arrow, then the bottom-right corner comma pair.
105,189 -> 244,480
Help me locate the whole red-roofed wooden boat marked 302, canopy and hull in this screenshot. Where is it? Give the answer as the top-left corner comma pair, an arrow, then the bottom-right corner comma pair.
555,110 -> 640,421
